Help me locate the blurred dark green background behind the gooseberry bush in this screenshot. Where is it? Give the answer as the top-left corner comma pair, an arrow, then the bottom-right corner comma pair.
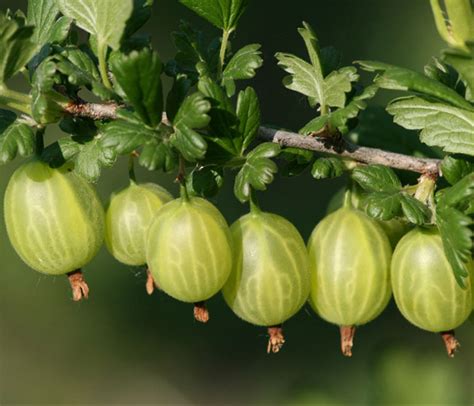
0,0 -> 474,405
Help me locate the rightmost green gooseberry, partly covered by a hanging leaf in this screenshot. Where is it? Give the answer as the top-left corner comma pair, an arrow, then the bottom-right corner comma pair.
392,227 -> 472,355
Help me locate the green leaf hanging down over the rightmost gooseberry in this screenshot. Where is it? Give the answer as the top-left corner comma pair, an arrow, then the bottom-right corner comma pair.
436,207 -> 473,287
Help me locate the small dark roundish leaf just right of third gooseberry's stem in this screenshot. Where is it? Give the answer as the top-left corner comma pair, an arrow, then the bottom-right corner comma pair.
186,166 -> 224,198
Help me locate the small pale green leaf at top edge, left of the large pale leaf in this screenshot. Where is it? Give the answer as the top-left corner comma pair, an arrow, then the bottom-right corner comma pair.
27,0 -> 72,48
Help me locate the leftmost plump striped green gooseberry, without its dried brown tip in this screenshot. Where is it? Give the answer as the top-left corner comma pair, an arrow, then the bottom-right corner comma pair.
5,160 -> 104,275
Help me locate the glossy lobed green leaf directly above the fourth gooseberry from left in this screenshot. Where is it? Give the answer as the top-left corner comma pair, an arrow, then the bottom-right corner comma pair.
234,142 -> 280,203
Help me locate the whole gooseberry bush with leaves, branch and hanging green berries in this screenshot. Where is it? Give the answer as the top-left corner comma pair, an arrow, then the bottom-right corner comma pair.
0,0 -> 474,356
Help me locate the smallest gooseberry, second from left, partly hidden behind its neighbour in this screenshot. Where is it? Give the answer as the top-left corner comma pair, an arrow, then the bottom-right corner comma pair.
105,181 -> 173,266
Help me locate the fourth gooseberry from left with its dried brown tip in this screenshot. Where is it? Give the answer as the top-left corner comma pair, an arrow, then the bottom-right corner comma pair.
223,210 -> 310,352
